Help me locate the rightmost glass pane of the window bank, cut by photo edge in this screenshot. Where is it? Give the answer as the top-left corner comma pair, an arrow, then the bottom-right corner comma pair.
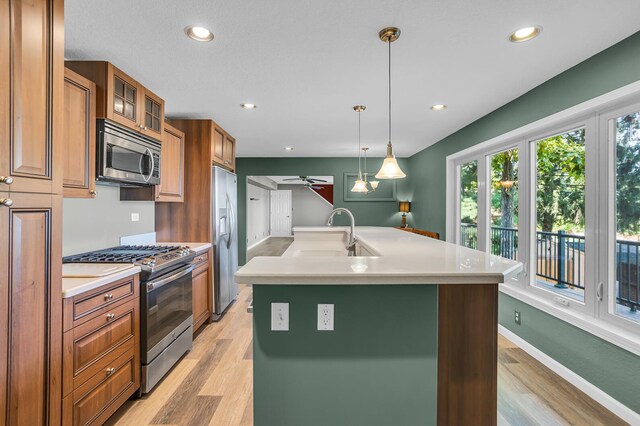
609,112 -> 640,323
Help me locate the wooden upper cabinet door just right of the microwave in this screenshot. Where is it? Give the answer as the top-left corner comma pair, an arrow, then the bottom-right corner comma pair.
157,124 -> 184,202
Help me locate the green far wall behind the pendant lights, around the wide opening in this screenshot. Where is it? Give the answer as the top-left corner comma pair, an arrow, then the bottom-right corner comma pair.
236,157 -> 411,265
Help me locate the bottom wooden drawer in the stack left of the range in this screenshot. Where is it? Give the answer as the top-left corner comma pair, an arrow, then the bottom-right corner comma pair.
62,349 -> 140,426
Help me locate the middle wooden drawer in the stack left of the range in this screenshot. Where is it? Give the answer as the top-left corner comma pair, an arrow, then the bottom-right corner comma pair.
63,298 -> 139,395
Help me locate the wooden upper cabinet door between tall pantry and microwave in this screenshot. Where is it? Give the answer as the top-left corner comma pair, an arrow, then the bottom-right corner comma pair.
61,68 -> 96,198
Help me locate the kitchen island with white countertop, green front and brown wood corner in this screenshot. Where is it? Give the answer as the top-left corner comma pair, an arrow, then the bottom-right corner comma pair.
236,227 -> 522,426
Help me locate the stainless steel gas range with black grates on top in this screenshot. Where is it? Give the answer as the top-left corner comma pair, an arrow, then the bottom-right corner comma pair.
62,245 -> 195,393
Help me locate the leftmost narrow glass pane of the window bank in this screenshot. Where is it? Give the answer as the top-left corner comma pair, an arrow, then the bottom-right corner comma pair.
458,161 -> 478,248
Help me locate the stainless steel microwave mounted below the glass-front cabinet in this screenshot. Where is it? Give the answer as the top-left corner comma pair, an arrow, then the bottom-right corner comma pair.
96,120 -> 161,186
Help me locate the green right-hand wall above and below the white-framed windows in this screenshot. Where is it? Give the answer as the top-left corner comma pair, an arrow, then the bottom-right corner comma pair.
407,32 -> 640,413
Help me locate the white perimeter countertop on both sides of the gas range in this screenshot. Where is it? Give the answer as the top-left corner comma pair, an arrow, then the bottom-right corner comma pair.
62,242 -> 211,298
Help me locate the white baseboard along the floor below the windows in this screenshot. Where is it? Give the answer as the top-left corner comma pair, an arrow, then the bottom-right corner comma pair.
498,325 -> 640,425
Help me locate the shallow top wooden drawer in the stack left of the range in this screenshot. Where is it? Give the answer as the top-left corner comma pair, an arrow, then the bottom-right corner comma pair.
64,275 -> 139,331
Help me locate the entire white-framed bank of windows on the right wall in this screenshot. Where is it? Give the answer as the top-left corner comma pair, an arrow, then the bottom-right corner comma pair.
447,93 -> 640,353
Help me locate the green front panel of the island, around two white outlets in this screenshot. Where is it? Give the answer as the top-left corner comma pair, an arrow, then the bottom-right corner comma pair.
253,285 -> 438,426
